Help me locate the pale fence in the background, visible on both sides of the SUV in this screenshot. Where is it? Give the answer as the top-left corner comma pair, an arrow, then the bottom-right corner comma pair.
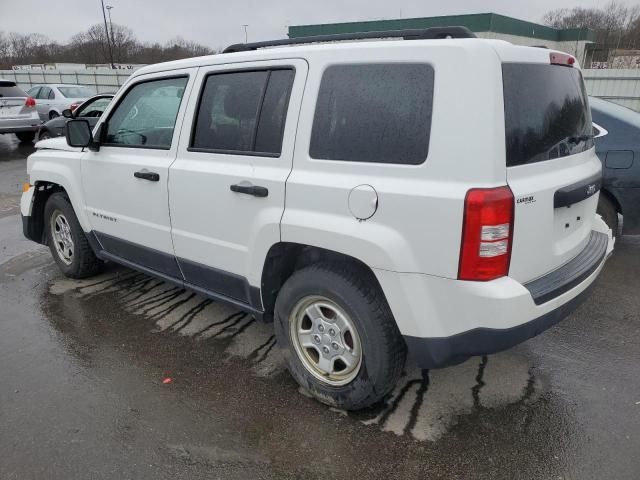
0,69 -> 640,112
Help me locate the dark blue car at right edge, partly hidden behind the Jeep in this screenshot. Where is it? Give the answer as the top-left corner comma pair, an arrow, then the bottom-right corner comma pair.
589,97 -> 640,235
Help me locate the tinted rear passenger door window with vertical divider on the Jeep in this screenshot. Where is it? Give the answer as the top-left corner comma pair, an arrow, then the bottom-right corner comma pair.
190,69 -> 294,155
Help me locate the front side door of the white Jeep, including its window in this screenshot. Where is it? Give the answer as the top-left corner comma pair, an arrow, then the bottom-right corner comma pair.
82,69 -> 196,278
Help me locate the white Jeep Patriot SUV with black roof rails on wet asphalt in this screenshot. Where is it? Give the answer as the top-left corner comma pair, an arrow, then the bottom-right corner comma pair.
22,27 -> 613,409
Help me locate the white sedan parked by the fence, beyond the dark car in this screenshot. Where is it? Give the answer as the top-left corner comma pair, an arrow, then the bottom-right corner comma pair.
27,83 -> 96,121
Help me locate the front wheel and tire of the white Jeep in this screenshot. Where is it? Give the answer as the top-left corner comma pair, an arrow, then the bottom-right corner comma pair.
44,192 -> 102,278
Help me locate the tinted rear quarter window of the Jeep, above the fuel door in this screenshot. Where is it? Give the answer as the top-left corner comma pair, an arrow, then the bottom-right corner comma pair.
309,63 -> 434,165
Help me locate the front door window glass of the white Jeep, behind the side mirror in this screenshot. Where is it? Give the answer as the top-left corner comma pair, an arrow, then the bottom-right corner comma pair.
104,77 -> 188,149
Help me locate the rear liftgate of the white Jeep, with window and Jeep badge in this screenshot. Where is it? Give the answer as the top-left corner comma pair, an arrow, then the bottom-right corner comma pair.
502,53 -> 602,283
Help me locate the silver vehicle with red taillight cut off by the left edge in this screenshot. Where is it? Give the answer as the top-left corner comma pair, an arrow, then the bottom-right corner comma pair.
0,78 -> 41,142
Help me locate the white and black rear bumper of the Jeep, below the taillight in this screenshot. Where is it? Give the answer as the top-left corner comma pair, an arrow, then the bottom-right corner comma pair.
376,218 -> 614,368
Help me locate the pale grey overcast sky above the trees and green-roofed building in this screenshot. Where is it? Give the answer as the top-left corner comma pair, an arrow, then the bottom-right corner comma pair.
0,0 -> 601,48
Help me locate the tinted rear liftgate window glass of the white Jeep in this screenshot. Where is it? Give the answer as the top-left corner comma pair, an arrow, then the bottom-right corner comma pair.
502,63 -> 594,167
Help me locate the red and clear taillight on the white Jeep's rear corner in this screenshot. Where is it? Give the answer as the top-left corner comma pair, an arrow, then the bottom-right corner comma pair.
458,186 -> 514,281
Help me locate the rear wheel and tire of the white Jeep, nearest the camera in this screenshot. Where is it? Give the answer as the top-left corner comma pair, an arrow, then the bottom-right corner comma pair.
275,263 -> 406,410
